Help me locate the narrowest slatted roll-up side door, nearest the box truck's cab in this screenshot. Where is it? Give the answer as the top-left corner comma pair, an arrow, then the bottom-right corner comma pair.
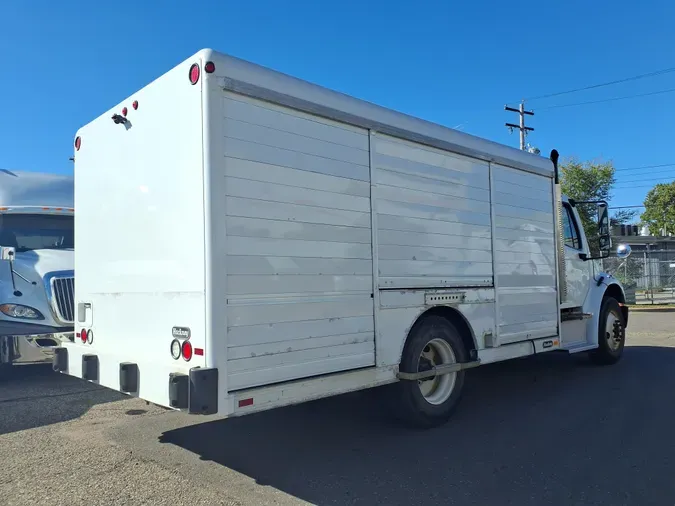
491,164 -> 558,344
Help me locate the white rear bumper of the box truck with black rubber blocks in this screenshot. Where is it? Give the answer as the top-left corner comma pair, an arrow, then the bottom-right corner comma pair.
52,343 -> 219,415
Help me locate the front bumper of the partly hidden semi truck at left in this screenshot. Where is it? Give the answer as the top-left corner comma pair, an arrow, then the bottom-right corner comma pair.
0,331 -> 74,364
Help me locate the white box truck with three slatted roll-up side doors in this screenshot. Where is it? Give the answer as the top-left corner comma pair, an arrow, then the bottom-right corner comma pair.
54,50 -> 628,426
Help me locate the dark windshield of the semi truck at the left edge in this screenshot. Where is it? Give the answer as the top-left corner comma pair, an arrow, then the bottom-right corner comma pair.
0,214 -> 74,252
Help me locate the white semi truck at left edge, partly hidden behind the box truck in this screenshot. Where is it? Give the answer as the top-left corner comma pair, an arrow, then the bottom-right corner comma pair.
0,170 -> 74,371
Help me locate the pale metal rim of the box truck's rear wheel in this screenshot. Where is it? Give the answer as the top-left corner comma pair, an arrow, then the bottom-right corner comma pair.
417,339 -> 457,405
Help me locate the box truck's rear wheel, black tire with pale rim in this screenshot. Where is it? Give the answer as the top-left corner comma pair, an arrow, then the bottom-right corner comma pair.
391,315 -> 468,429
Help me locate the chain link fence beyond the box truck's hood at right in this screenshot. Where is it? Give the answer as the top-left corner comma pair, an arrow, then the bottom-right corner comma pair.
603,249 -> 675,304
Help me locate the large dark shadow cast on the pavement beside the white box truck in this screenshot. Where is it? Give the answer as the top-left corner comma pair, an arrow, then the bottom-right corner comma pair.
161,347 -> 675,506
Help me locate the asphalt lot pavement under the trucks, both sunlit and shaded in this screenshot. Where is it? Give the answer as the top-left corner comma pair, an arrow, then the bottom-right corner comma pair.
0,312 -> 675,506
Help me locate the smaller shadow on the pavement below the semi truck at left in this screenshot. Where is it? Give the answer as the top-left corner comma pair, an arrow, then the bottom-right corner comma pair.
0,364 -> 125,436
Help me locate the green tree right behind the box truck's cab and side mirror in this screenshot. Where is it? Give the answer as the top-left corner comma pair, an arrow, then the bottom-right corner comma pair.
560,159 -> 636,254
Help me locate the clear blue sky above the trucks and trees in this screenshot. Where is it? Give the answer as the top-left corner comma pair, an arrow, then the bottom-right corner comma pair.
0,0 -> 675,214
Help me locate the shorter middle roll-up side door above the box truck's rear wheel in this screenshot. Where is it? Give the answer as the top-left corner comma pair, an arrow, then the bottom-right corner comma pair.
371,134 -> 492,289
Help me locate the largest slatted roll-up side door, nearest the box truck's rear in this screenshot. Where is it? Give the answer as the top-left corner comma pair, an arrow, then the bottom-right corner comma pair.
224,93 -> 375,391
